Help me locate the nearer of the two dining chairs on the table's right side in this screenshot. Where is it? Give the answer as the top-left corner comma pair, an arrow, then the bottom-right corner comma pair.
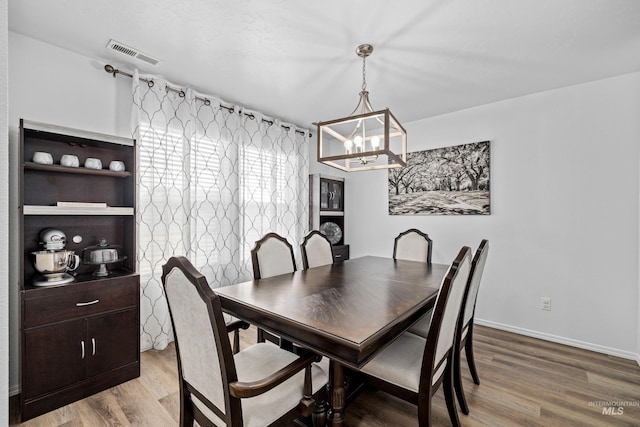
360,246 -> 471,427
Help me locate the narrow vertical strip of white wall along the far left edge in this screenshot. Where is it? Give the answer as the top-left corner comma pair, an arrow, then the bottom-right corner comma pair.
0,0 -> 9,425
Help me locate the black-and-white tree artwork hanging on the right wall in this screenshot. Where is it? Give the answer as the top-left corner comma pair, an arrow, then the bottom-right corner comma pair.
389,141 -> 491,215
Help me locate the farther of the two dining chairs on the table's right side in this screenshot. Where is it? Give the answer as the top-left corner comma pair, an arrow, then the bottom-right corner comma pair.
409,239 -> 489,415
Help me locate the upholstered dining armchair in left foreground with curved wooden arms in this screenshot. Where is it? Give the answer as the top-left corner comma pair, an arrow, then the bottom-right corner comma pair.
162,257 -> 328,427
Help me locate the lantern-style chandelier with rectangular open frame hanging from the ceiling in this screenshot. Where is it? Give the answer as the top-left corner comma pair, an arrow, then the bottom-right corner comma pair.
317,44 -> 407,172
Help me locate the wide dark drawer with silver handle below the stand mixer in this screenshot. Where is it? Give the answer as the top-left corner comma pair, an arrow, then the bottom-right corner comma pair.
23,275 -> 140,328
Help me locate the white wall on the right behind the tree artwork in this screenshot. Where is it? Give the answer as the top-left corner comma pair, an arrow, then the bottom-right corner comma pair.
345,73 -> 640,359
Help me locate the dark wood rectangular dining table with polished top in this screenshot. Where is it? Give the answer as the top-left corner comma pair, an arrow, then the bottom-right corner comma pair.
215,256 -> 449,426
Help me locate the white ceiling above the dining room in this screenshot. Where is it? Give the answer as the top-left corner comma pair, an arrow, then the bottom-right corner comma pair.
9,0 -> 640,127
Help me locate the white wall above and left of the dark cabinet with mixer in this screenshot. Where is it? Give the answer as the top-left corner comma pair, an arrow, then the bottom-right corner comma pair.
8,32 -> 131,394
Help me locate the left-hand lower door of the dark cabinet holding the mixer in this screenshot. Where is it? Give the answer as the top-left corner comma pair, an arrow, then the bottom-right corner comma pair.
22,319 -> 87,399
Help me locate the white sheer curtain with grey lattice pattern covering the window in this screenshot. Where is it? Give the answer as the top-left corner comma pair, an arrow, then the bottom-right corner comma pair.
132,71 -> 308,350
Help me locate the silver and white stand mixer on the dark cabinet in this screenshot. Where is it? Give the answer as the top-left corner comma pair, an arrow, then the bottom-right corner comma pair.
31,228 -> 80,286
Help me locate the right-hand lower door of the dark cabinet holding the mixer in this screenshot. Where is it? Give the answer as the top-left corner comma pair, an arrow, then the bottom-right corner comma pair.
87,308 -> 140,376
